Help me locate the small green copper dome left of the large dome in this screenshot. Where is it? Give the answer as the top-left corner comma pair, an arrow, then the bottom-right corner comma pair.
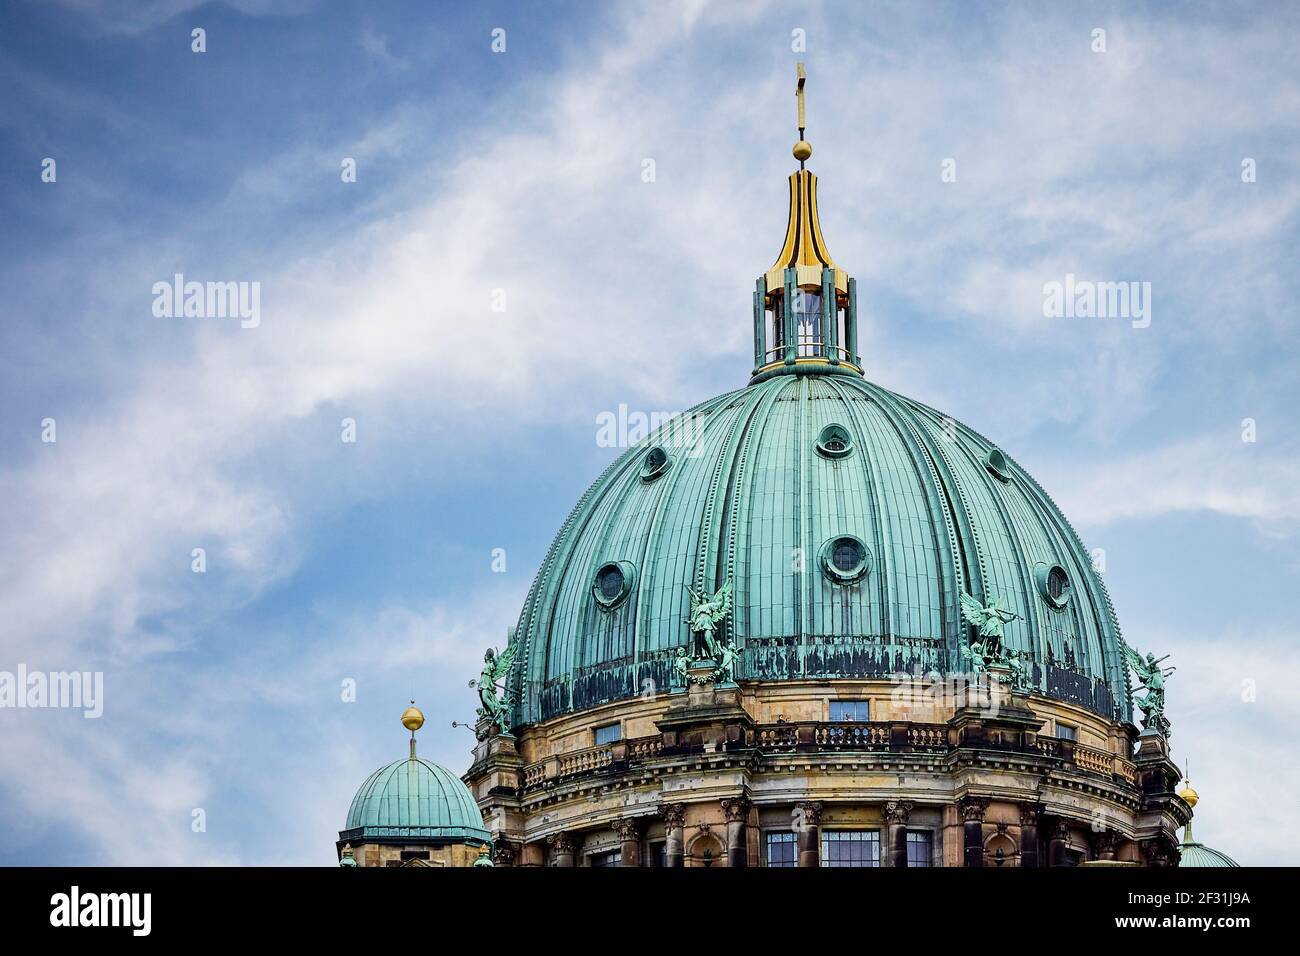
339,756 -> 491,844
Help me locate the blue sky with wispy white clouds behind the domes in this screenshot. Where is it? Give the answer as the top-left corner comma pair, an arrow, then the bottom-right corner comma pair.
0,0 -> 1300,865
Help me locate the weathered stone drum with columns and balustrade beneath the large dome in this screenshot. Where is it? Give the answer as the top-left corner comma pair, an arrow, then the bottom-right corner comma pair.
464,680 -> 1191,868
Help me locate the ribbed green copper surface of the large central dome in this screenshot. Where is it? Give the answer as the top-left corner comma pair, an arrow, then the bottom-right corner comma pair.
512,375 -> 1130,723
